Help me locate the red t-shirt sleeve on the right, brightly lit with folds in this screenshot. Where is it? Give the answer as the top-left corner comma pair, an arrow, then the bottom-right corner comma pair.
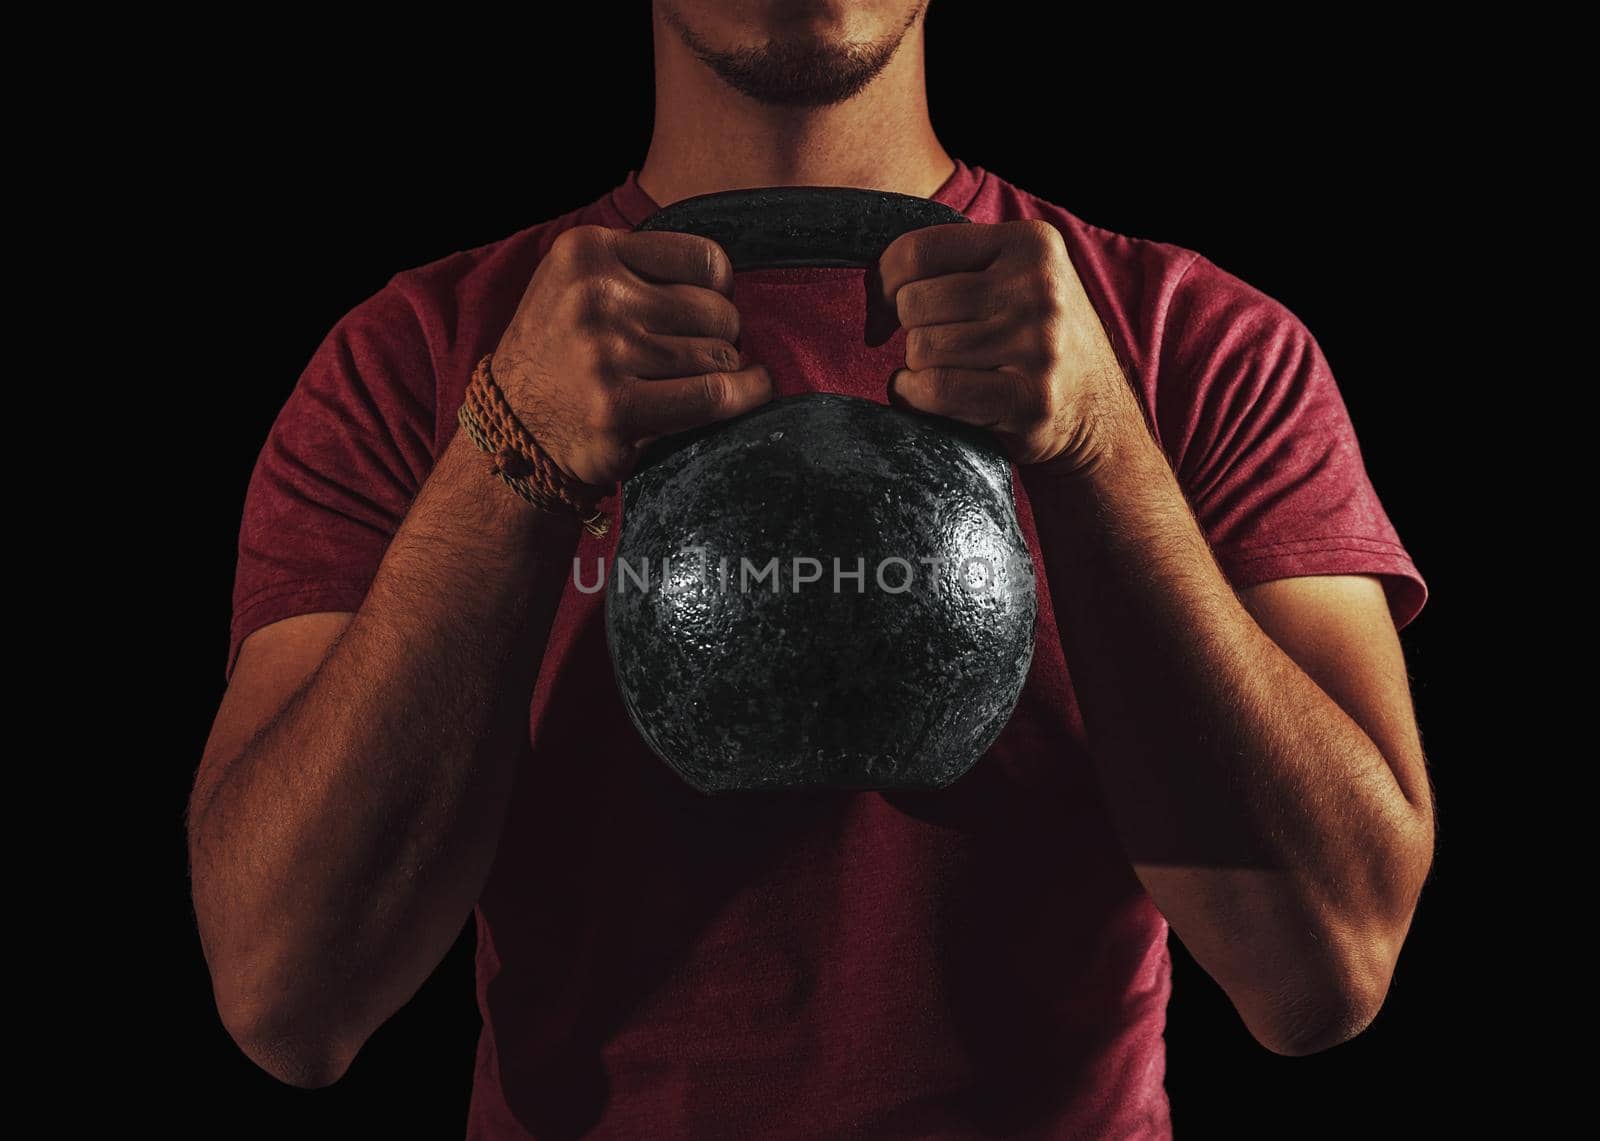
1157,256 -> 1427,629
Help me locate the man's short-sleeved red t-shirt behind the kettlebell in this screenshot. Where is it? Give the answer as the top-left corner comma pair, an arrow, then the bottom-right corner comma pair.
227,163 -> 1427,1138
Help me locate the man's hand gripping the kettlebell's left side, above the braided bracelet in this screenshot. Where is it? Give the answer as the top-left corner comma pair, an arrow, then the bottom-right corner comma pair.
490,226 -> 773,486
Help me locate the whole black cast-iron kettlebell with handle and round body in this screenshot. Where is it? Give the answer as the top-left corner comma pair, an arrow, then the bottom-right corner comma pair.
605,187 -> 1037,792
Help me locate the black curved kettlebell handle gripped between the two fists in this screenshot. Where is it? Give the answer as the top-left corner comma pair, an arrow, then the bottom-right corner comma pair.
635,186 -> 970,270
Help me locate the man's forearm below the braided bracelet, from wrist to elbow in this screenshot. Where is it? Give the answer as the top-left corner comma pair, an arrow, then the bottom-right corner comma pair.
190,435 -> 576,1077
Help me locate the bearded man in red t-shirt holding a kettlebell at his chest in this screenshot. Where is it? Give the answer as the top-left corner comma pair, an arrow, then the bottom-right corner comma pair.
189,0 -> 1432,1138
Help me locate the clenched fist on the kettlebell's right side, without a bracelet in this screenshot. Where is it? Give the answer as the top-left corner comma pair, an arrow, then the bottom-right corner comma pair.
874,221 -> 1139,472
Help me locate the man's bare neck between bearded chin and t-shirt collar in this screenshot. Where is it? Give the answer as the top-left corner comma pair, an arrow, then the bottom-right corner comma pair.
638,13 -> 955,206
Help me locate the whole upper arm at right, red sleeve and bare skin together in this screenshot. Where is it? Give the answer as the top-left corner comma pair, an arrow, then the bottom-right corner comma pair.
1154,256 -> 1432,827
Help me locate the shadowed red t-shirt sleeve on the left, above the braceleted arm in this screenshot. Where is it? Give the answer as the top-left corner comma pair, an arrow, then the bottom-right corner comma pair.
224,278 -> 437,679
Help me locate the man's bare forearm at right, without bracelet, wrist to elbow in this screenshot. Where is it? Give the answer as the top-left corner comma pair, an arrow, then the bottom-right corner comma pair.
1024,388 -> 1430,1051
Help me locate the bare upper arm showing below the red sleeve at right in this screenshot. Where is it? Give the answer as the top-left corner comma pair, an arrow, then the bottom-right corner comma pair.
1238,575 -> 1432,821
